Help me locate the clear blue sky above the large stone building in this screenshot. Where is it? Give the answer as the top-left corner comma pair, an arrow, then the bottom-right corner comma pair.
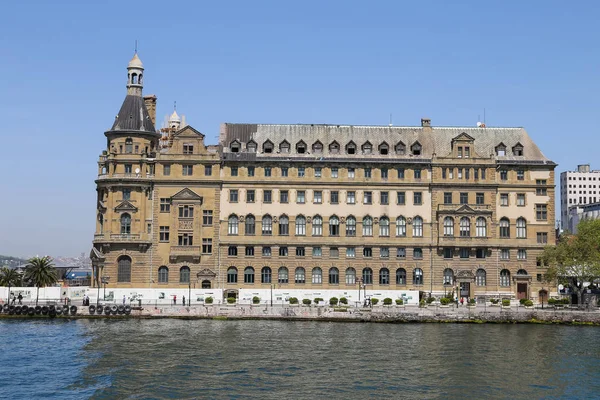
0,0 -> 600,255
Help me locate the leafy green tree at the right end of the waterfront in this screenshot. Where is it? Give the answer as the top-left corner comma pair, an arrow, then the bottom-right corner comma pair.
542,220 -> 600,305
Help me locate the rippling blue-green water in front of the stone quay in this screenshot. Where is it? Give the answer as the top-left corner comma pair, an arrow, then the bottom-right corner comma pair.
0,319 -> 600,399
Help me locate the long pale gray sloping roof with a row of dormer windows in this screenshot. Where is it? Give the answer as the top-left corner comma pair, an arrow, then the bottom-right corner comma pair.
220,123 -> 553,164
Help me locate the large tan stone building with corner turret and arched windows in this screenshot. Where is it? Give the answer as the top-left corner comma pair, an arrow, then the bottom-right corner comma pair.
92,57 -> 556,299
